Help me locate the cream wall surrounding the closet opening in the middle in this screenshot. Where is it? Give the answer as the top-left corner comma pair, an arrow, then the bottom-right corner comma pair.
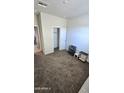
40,12 -> 66,54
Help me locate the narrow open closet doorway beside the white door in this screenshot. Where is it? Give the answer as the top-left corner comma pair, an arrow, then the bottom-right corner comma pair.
54,28 -> 60,51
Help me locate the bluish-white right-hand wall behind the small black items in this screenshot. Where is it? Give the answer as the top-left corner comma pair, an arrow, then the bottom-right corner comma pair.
66,15 -> 89,53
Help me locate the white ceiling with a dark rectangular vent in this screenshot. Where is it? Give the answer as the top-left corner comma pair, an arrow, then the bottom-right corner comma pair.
34,0 -> 89,18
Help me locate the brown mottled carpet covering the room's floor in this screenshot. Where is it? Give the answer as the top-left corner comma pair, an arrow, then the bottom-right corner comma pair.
34,51 -> 89,93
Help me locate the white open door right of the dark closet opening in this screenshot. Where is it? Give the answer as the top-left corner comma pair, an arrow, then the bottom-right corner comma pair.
59,27 -> 66,50
